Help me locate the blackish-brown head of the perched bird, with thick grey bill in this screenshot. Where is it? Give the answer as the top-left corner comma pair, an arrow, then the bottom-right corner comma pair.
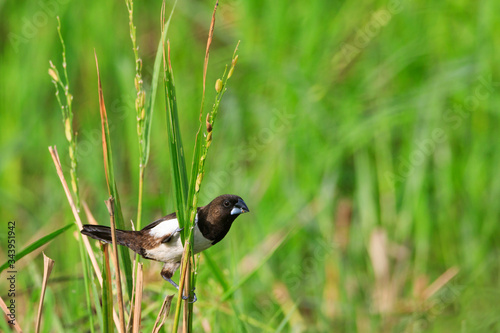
198,194 -> 250,244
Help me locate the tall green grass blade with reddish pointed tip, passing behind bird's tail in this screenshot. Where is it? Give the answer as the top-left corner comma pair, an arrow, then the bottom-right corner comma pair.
95,54 -> 133,299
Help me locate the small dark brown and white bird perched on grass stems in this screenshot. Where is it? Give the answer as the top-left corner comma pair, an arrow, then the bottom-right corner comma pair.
80,194 -> 250,302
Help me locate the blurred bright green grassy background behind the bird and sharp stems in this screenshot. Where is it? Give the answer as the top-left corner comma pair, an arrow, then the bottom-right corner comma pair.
0,0 -> 500,332
